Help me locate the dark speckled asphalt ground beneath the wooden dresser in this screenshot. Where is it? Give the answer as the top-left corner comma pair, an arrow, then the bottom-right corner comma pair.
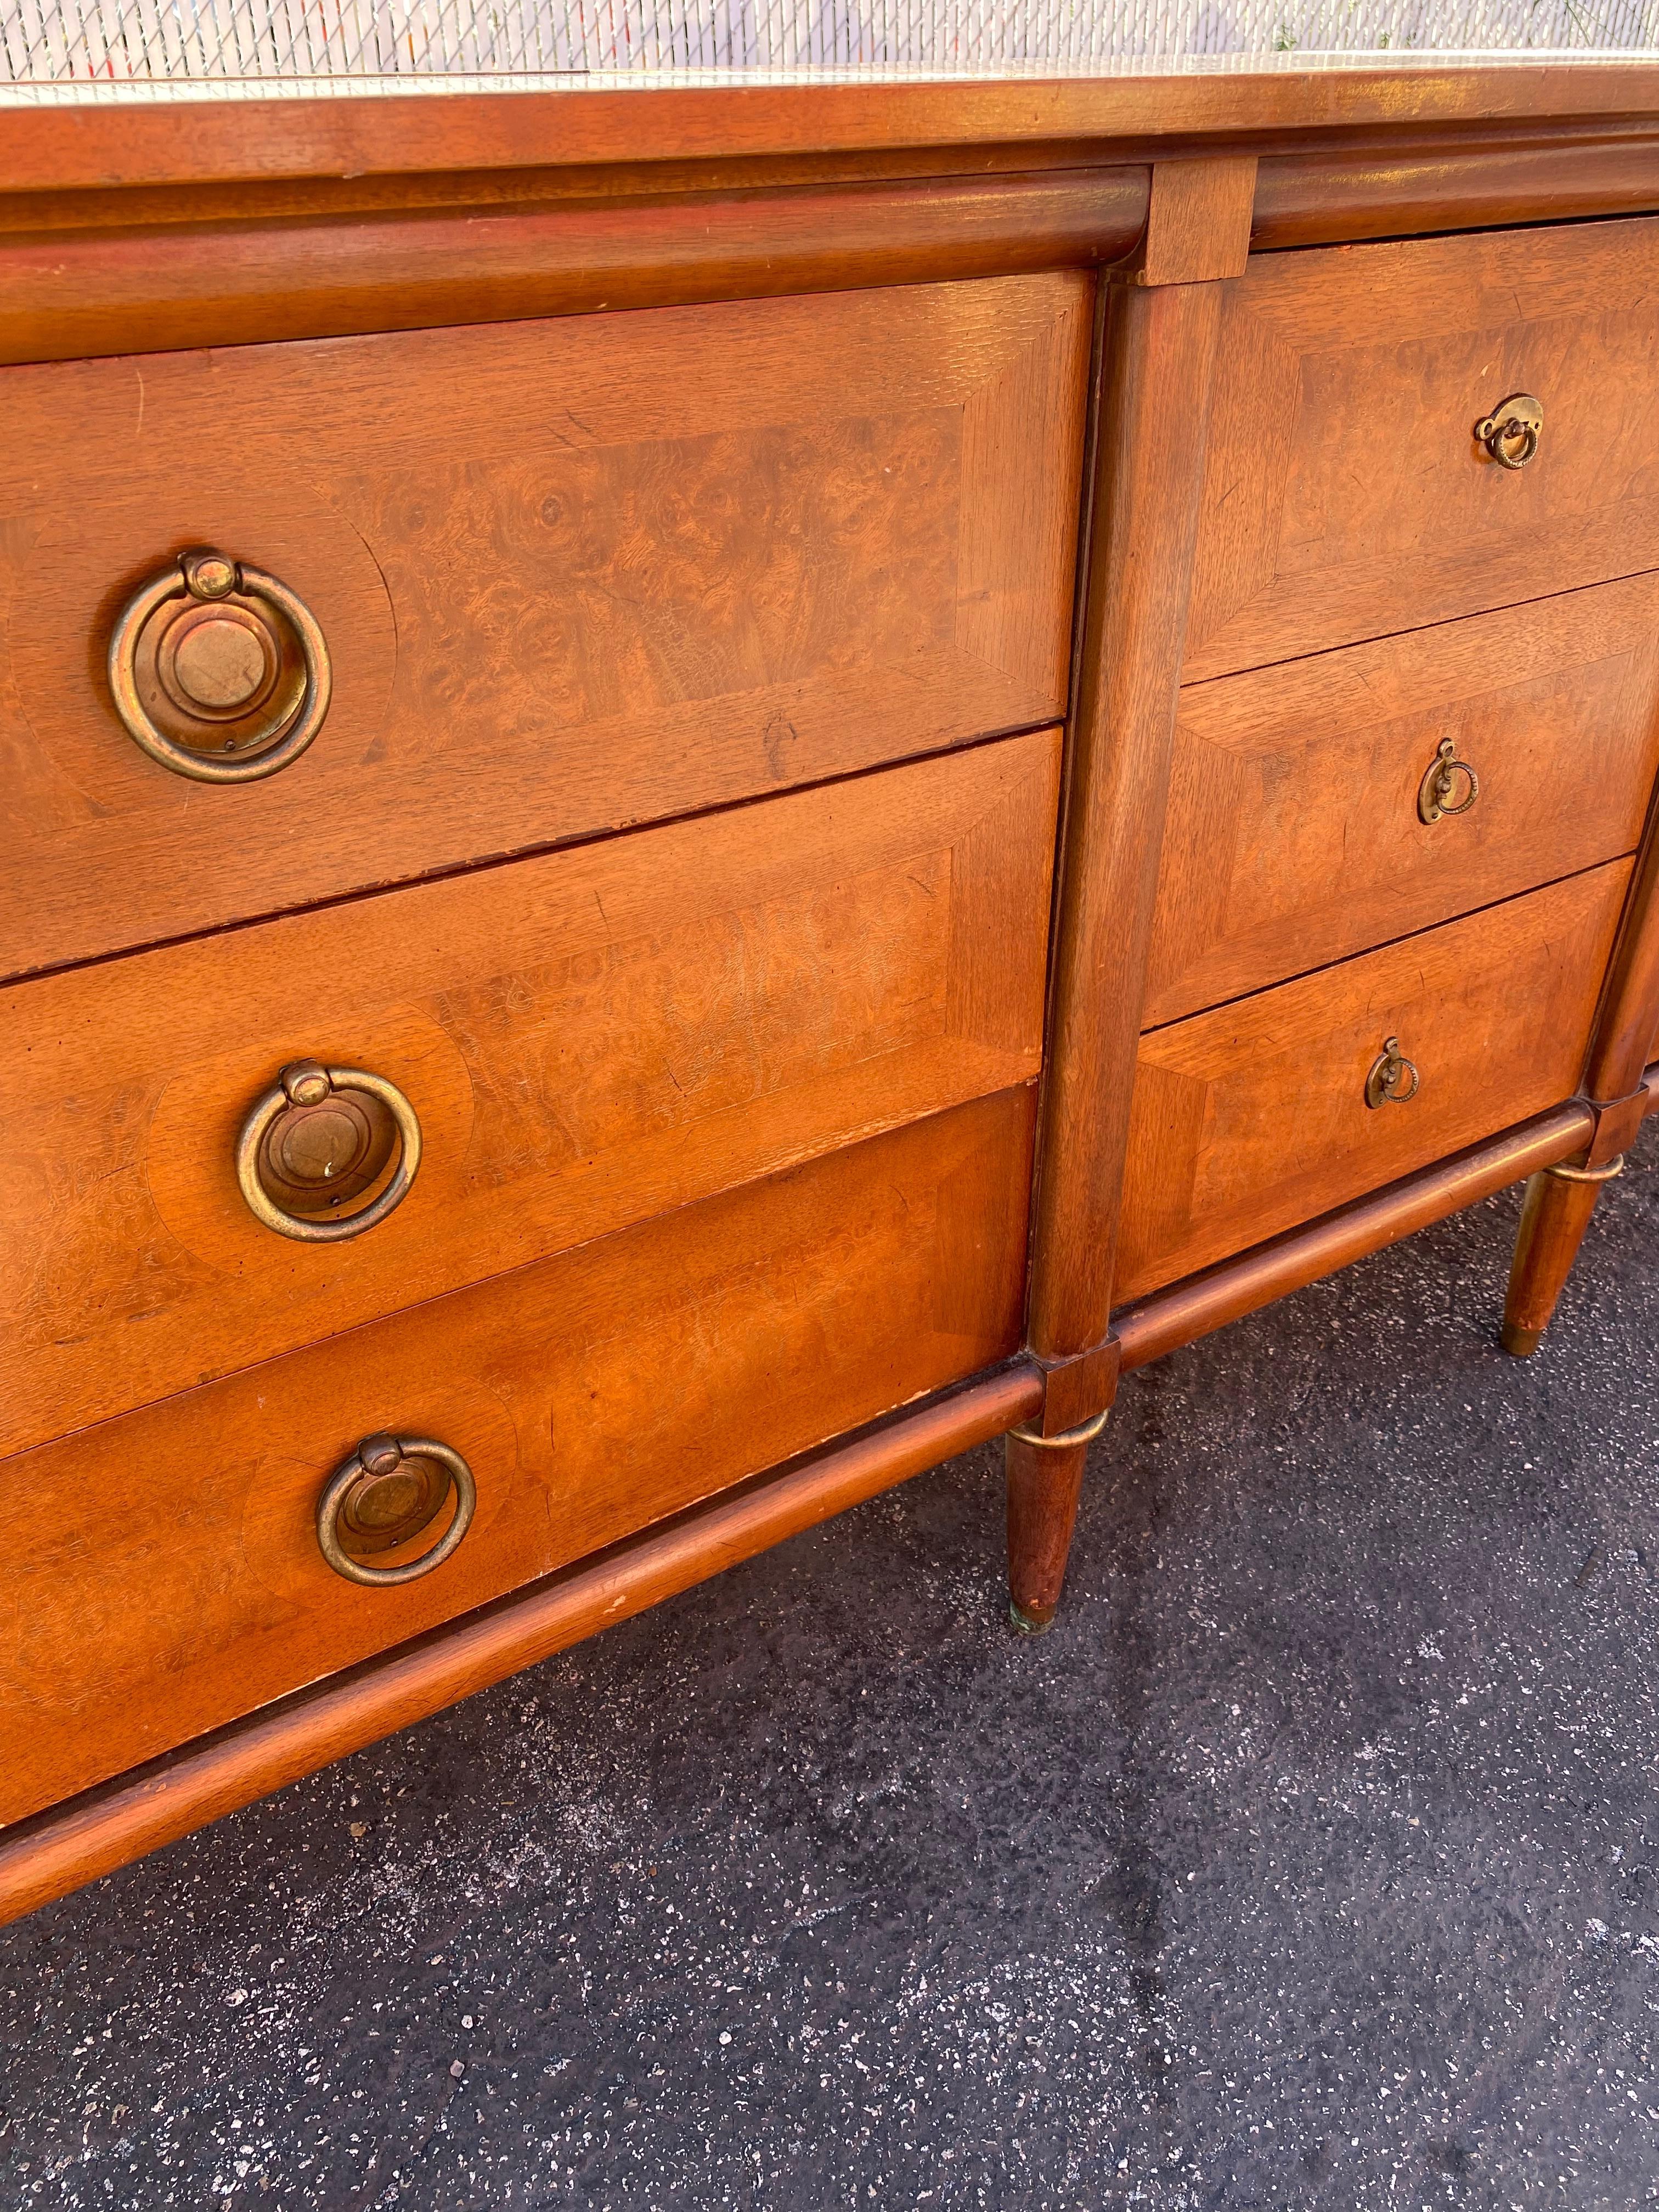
0,1132 -> 1659,2212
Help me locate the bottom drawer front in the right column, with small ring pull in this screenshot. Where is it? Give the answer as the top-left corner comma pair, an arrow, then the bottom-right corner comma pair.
1117,860 -> 1630,1303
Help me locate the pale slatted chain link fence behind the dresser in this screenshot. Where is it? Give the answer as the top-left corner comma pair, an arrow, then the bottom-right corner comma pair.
0,0 -> 1659,99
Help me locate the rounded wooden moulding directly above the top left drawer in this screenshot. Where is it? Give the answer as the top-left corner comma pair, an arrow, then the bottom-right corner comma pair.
0,168 -> 1148,360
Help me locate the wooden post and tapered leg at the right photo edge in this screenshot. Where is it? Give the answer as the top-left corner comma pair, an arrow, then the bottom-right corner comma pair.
1502,822 -> 1659,1361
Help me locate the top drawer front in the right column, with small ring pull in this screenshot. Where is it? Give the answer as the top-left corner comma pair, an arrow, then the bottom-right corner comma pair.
1186,219 -> 1659,679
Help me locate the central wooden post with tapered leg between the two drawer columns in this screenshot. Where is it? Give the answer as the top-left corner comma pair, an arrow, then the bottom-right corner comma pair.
1007,157 -> 1256,1633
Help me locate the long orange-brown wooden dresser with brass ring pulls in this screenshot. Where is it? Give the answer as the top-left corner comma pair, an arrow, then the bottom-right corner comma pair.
0,64 -> 1659,1914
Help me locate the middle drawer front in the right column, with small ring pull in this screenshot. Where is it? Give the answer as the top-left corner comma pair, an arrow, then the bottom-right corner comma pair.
1142,575 -> 1659,1029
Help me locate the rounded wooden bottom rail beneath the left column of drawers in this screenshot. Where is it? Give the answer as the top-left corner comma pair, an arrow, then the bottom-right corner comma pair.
0,1365 -> 1042,1922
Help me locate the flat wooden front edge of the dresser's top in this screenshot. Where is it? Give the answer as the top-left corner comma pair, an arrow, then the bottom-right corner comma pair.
0,60 -> 1659,194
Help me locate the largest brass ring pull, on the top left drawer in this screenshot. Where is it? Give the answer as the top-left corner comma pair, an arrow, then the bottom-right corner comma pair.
109,551 -> 334,783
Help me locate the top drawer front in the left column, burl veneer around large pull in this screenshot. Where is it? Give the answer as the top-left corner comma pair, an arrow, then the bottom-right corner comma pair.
0,272 -> 1093,973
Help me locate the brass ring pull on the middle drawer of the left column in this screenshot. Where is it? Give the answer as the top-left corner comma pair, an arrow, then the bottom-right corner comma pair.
236,1059 -> 420,1243
